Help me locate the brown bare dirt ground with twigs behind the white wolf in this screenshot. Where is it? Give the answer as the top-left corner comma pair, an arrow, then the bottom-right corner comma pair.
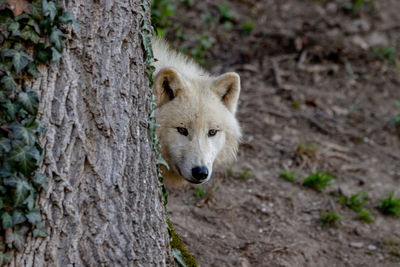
162,0 -> 400,267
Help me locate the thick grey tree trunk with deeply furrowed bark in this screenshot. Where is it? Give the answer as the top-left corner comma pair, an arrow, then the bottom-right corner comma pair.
10,0 -> 170,267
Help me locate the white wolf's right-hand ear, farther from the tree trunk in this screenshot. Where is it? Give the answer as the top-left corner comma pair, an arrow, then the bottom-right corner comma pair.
211,72 -> 240,114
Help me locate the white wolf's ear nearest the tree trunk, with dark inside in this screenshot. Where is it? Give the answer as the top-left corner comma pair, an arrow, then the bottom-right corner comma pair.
154,68 -> 183,107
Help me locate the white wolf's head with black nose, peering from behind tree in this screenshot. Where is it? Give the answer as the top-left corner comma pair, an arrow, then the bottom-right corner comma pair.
154,68 -> 241,184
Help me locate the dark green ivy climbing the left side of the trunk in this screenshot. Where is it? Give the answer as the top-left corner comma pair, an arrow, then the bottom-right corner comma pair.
0,0 -> 76,265
